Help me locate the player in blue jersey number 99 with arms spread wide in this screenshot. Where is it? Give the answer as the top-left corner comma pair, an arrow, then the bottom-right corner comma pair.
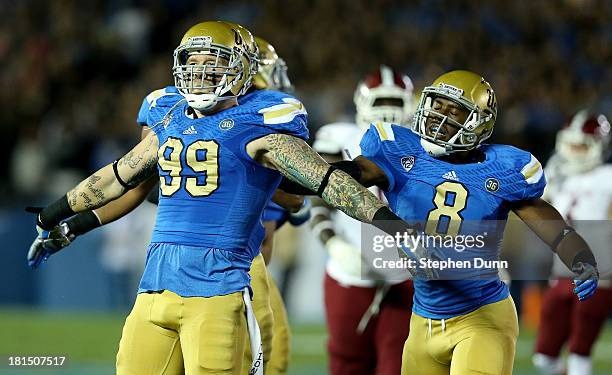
31,21 -> 411,374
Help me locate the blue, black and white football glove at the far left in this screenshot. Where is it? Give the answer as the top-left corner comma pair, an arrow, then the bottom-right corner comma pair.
28,223 -> 76,269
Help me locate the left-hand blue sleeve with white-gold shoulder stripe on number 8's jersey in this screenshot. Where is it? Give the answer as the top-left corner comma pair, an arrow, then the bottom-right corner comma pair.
359,123 -> 395,191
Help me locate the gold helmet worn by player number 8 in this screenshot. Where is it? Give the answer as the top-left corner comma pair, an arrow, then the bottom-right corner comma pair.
414,70 -> 497,156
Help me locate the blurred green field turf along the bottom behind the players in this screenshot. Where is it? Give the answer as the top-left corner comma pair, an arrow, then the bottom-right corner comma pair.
0,309 -> 612,375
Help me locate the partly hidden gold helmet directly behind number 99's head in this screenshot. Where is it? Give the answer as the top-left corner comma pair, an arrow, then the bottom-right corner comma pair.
253,36 -> 293,92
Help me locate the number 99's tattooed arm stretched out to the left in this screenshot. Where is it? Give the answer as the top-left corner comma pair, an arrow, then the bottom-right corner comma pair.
38,133 -> 159,230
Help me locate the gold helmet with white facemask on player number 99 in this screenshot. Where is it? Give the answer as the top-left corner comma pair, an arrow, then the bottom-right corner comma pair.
172,21 -> 256,111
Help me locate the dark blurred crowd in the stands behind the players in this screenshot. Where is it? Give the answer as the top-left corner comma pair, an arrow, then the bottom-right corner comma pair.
0,0 -> 612,204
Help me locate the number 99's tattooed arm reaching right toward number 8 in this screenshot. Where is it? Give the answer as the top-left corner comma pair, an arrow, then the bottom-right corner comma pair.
265,134 -> 385,223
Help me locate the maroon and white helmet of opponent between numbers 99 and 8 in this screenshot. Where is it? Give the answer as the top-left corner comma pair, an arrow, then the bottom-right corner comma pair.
353,65 -> 414,129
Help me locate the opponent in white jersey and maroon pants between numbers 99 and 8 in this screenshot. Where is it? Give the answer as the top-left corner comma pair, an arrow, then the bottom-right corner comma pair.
312,65 -> 414,375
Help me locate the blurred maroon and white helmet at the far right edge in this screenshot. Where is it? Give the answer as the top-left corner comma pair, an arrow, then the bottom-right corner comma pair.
555,110 -> 610,173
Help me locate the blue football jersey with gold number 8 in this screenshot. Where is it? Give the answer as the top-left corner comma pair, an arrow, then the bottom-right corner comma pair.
360,123 -> 546,319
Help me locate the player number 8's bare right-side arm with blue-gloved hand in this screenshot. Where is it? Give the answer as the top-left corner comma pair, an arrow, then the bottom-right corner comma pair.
513,199 -> 599,300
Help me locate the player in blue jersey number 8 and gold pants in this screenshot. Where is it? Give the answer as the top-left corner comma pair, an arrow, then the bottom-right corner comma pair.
280,70 -> 598,375
